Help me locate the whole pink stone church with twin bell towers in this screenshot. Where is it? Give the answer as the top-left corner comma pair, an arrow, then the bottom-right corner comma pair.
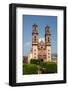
28,24 -> 51,63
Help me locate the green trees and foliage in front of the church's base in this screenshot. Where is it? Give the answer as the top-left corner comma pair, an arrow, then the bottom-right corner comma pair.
23,59 -> 57,74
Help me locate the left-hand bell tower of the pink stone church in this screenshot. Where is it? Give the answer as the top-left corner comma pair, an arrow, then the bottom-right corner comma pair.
32,24 -> 38,59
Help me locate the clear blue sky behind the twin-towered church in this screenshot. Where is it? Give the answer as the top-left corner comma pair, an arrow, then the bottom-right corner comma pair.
22,15 -> 57,55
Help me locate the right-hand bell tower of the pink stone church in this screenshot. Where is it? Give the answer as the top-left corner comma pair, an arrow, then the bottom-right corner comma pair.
45,25 -> 51,61
